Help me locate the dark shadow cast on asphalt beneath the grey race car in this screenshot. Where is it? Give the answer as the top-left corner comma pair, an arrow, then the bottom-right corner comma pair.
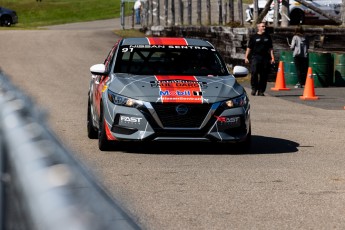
103,135 -> 299,155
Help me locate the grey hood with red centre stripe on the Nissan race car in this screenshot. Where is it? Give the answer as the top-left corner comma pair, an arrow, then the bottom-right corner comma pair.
108,74 -> 244,103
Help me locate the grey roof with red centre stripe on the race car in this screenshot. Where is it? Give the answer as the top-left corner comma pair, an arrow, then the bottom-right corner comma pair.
121,37 -> 214,48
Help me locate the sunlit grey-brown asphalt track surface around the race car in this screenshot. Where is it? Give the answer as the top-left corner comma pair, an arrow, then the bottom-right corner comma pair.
0,20 -> 345,230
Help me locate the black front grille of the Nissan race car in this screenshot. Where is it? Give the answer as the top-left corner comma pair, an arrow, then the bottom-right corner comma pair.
152,103 -> 211,128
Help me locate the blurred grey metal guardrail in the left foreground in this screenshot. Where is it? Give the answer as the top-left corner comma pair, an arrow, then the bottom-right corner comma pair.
0,70 -> 140,230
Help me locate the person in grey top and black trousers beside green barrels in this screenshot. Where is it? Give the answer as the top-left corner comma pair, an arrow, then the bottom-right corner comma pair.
290,26 -> 309,88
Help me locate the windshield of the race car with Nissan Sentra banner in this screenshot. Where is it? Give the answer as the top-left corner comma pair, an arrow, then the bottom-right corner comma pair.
114,46 -> 228,76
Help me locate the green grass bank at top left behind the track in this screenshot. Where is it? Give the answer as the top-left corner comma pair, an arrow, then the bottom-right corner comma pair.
1,0 -> 133,29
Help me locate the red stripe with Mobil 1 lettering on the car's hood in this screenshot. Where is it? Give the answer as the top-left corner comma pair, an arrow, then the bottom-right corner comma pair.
156,75 -> 203,104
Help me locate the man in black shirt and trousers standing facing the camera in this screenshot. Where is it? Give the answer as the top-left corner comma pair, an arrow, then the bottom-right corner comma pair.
244,22 -> 275,96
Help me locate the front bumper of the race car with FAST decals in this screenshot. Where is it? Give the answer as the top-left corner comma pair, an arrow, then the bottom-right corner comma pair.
104,98 -> 250,142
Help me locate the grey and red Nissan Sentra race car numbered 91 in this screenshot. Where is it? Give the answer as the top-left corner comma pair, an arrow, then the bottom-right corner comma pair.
87,37 -> 251,151
